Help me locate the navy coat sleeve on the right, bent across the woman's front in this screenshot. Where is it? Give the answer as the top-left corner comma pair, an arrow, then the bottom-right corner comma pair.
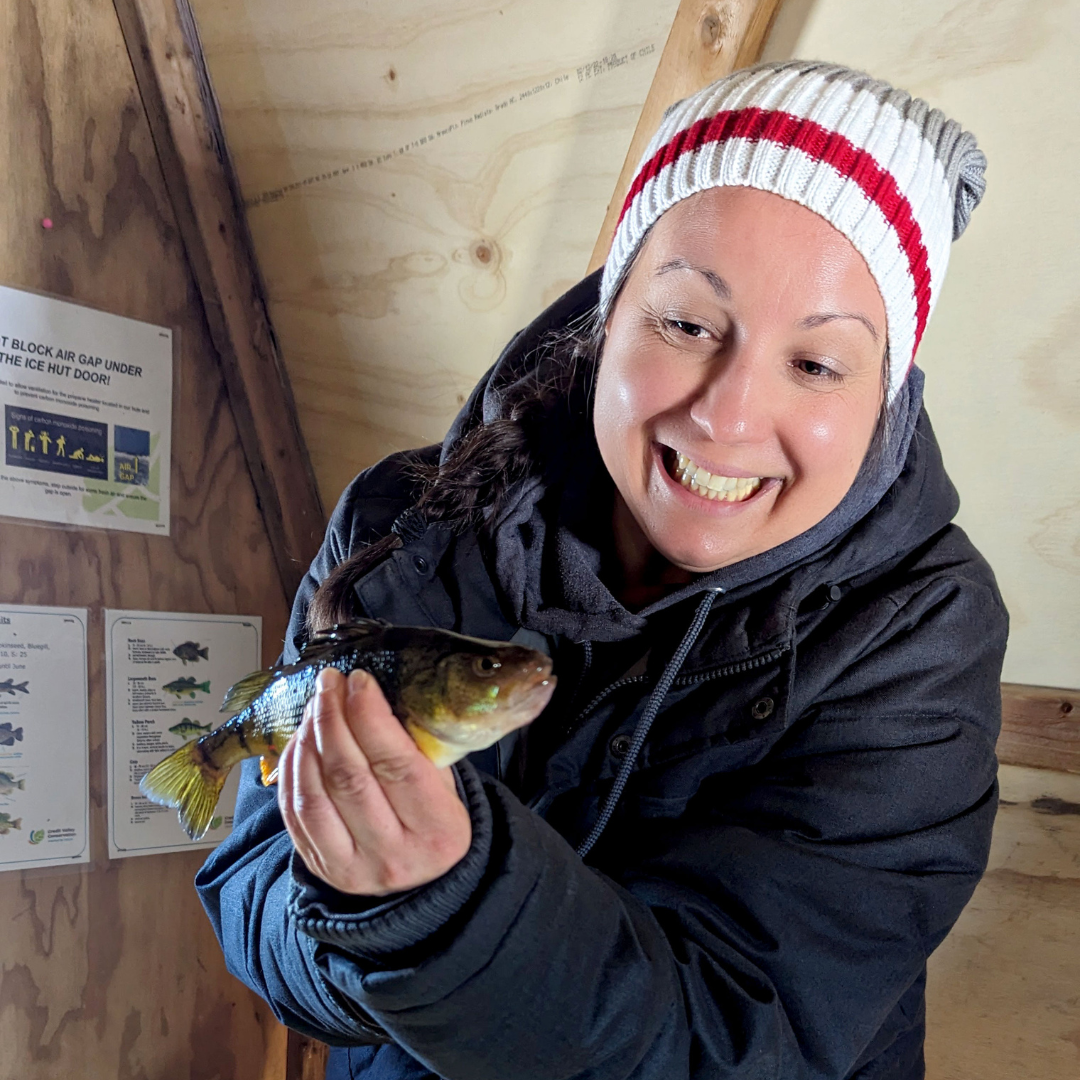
288,579 -> 1005,1080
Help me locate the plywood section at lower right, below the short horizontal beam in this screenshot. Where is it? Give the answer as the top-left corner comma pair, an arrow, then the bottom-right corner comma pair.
926,765 -> 1080,1080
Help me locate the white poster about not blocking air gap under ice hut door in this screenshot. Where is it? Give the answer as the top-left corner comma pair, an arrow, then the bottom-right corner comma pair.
0,285 -> 173,536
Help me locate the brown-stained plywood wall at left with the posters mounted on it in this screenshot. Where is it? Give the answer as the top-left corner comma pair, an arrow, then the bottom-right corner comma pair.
0,0 -> 287,1080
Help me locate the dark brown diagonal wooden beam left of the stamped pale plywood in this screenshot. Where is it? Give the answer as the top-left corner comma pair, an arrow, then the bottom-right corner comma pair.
113,0 -> 326,597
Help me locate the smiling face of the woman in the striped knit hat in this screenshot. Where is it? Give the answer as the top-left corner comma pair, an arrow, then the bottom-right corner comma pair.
595,188 -> 886,572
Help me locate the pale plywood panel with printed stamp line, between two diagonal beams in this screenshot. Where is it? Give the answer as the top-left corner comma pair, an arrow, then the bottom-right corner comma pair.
185,0 -> 677,504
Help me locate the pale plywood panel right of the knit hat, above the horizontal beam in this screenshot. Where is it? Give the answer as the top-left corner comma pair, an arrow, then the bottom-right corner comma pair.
767,0 -> 1080,688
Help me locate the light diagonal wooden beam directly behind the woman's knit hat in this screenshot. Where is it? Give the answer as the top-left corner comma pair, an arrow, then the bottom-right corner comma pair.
589,0 -> 782,272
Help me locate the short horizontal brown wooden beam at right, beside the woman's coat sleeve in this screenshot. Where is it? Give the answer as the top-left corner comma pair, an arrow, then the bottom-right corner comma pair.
998,683 -> 1080,772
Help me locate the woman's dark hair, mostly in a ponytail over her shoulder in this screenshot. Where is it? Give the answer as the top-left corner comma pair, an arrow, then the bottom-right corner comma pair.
307,276 -> 894,634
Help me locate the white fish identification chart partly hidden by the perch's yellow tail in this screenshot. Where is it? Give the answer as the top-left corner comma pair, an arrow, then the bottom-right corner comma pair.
105,610 -> 262,859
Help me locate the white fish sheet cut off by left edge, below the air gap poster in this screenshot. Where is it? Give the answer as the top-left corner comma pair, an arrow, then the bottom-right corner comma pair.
0,604 -> 90,870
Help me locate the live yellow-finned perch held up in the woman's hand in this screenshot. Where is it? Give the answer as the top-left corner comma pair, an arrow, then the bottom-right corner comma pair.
139,620 -> 555,840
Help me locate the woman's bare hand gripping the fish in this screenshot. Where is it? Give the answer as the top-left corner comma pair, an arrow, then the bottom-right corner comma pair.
278,667 -> 472,896
